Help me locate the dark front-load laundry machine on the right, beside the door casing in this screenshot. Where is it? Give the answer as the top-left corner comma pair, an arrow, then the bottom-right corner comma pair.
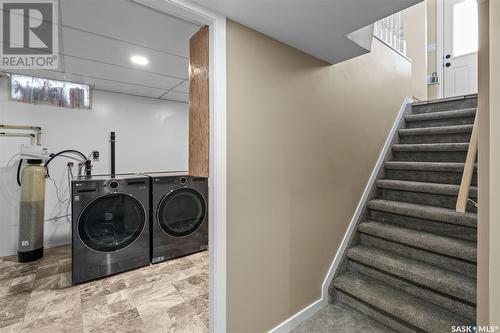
147,173 -> 208,264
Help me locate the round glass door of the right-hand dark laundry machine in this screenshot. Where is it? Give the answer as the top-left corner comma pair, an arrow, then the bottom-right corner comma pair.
157,187 -> 207,237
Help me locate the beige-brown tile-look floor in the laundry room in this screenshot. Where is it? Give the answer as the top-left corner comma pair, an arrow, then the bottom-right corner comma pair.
0,246 -> 208,333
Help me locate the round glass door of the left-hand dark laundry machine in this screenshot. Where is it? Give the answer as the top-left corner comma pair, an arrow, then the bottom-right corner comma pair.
78,193 -> 146,252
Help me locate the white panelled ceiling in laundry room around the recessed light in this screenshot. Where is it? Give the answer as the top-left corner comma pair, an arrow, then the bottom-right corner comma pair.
2,0 -> 200,102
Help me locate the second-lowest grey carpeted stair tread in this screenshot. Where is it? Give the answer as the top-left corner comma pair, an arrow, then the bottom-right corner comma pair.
348,245 -> 476,304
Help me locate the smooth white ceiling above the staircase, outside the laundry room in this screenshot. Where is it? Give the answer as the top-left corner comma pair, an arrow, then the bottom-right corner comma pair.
192,0 -> 422,64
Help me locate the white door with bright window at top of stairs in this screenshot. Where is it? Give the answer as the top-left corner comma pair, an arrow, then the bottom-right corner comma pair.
443,0 -> 479,97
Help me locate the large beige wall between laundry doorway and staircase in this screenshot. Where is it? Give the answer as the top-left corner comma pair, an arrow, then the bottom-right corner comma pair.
227,21 -> 412,333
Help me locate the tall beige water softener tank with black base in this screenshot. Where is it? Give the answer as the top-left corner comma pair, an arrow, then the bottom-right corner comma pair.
17,160 -> 46,262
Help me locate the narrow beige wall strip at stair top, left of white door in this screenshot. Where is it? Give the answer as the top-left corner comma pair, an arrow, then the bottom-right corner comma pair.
404,1 -> 427,101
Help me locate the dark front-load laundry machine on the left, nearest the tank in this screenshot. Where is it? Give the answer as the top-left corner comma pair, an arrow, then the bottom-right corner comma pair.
72,175 -> 149,283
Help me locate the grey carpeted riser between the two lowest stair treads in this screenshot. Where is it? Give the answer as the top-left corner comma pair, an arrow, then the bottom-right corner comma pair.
350,261 -> 476,319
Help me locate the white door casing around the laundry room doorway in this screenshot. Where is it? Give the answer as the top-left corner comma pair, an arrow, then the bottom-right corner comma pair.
134,0 -> 227,333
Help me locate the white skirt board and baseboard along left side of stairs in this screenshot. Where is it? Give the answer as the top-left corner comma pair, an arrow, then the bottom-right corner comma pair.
268,97 -> 414,333
